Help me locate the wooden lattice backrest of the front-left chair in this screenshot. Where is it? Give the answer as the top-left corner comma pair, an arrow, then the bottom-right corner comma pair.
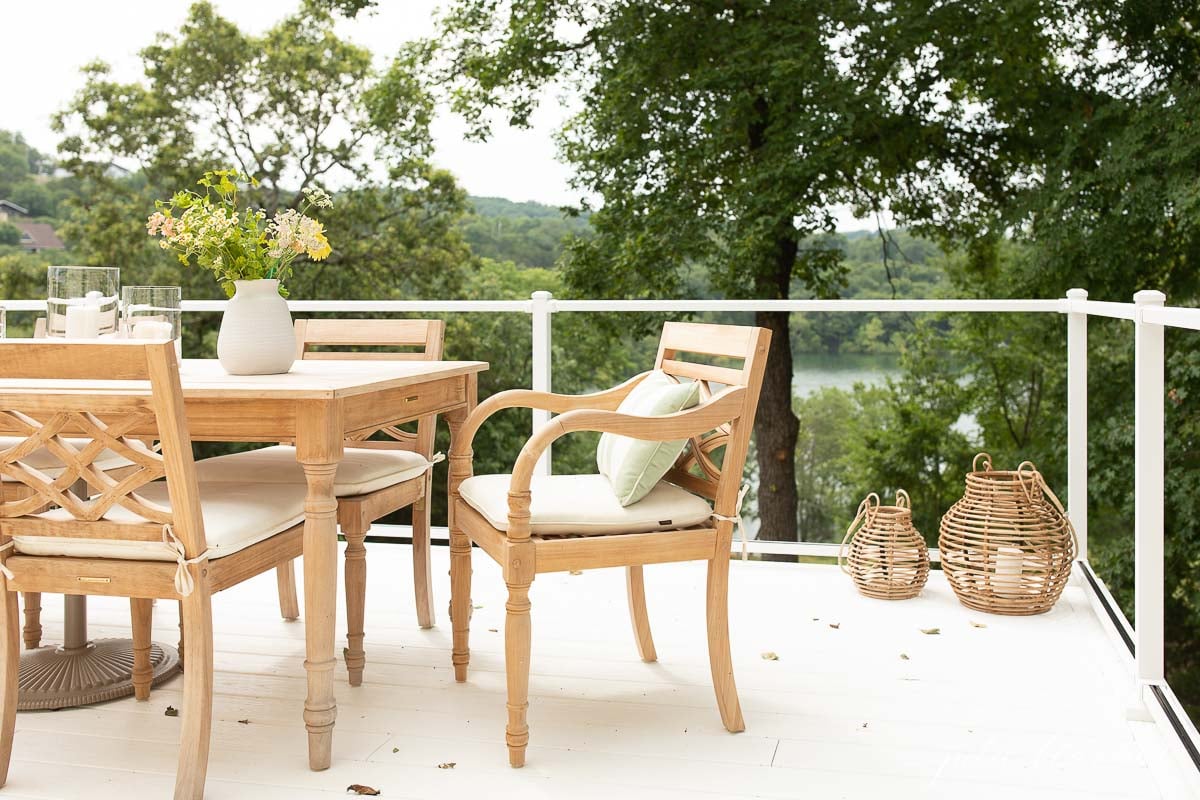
0,339 -> 206,558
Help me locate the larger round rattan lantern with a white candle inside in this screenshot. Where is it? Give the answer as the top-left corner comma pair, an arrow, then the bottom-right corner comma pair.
937,453 -> 1078,614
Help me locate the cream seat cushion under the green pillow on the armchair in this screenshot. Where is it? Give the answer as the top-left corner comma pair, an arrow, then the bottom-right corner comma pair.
458,475 -> 713,535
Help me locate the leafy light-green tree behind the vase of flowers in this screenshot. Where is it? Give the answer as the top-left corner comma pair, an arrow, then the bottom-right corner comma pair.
54,2 -> 456,307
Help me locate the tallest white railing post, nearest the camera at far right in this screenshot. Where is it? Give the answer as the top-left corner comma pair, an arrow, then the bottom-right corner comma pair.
1133,290 -> 1166,708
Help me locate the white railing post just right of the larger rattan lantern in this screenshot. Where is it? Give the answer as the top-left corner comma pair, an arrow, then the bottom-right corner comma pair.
1067,289 -> 1087,561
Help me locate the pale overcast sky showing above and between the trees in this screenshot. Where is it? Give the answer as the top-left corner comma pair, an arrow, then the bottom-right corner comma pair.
9,0 -> 865,229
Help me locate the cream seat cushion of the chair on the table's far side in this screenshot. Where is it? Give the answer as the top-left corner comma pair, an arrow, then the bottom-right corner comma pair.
196,445 -> 430,498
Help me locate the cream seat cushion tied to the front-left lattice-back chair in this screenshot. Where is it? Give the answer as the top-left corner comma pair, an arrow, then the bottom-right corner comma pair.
13,481 -> 305,561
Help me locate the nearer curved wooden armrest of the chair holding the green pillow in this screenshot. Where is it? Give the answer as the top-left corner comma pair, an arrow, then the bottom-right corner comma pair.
509,386 -> 746,501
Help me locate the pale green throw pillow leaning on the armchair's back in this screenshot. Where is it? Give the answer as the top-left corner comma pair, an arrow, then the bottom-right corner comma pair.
596,369 -> 700,506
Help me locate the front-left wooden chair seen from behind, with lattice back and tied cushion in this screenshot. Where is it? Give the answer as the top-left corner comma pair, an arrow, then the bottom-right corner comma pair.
0,339 -> 305,799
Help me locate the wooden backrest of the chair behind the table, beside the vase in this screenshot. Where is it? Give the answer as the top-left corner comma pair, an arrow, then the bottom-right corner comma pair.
295,319 -> 445,458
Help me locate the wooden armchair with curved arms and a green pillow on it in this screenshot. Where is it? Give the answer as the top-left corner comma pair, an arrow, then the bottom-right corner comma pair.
450,323 -> 770,766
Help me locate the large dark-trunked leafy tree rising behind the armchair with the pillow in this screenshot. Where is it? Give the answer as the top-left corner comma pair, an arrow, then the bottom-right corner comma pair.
420,0 -> 1089,539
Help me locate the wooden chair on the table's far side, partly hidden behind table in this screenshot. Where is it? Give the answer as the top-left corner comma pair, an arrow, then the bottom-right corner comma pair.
198,319 -> 445,686
